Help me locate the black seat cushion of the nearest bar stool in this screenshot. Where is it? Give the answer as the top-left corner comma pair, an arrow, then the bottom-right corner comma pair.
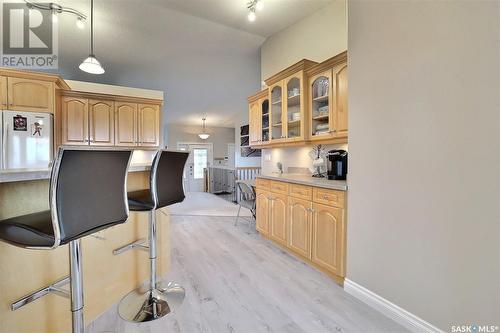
0,210 -> 54,247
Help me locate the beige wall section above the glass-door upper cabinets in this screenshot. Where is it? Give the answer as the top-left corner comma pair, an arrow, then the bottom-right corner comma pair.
261,0 -> 347,80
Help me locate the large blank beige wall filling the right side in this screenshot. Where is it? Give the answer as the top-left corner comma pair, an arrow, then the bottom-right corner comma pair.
347,1 -> 500,331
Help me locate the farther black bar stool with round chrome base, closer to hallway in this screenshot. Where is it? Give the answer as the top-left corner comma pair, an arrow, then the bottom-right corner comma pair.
113,150 -> 189,323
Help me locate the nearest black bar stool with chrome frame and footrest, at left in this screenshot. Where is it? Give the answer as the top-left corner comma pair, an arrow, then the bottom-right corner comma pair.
0,148 -> 132,333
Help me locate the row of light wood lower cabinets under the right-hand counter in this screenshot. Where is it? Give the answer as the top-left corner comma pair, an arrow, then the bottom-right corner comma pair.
256,179 -> 346,278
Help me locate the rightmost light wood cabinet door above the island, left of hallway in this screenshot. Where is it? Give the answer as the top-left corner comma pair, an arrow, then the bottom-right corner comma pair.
138,104 -> 160,147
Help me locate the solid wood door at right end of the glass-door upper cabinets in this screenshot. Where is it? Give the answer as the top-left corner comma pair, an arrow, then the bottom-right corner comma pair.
332,64 -> 348,138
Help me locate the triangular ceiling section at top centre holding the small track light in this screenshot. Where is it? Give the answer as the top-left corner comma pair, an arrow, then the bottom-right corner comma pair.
153,0 -> 334,37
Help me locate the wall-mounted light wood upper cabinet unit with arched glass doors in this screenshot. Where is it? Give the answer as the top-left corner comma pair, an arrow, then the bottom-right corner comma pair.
248,52 -> 348,148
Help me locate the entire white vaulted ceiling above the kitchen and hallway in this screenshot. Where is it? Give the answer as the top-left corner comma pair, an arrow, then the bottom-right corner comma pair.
42,0 -> 332,127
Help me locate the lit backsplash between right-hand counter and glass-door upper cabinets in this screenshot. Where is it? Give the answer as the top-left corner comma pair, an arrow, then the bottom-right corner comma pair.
261,144 -> 348,174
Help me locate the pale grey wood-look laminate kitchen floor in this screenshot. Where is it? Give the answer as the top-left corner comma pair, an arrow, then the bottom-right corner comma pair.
87,216 -> 407,333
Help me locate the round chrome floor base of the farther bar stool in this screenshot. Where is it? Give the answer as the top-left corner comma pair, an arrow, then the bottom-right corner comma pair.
118,282 -> 186,323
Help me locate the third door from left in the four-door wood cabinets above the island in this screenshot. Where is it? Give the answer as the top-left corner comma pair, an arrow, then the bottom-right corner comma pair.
115,102 -> 138,146
